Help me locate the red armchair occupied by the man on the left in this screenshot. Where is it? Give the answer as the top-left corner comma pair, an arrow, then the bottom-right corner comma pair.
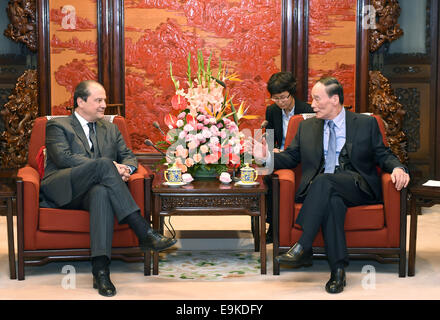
17,116 -> 152,280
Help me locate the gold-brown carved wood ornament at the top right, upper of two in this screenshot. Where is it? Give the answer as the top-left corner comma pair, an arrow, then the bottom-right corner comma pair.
369,0 -> 403,52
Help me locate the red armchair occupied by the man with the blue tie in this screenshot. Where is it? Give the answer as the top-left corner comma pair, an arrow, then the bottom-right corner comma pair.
272,115 -> 406,277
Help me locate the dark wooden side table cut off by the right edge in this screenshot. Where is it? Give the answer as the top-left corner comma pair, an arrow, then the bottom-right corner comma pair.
408,184 -> 440,277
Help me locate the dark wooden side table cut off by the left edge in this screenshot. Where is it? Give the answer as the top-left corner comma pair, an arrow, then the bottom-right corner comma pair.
0,179 -> 17,279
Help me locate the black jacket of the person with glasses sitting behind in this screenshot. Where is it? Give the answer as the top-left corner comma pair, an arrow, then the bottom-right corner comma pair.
266,98 -> 313,149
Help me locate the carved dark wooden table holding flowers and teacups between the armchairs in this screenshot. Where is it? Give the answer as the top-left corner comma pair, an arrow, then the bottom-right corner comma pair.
152,174 -> 267,275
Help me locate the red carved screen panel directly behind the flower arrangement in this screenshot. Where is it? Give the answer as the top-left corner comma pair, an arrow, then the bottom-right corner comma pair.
124,0 -> 281,152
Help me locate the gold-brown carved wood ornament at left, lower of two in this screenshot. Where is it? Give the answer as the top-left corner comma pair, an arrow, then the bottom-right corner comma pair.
0,70 -> 38,168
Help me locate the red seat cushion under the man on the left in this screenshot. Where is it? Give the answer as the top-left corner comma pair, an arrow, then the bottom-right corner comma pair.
38,208 -> 129,232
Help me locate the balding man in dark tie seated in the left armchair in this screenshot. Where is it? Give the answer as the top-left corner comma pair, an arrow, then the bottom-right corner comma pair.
40,80 -> 176,296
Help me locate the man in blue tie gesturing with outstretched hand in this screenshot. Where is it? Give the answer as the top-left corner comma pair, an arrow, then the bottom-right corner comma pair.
254,77 -> 409,293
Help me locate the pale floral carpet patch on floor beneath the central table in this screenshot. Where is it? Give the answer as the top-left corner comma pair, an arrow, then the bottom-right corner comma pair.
158,250 -> 260,281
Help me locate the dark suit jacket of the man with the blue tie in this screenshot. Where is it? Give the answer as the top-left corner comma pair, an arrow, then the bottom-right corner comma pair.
274,111 -> 404,201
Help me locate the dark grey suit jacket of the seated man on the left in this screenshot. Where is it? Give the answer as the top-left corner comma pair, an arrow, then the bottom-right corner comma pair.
40,115 -> 137,207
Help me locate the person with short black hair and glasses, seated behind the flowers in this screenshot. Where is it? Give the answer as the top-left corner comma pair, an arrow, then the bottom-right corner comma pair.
265,72 -> 313,243
